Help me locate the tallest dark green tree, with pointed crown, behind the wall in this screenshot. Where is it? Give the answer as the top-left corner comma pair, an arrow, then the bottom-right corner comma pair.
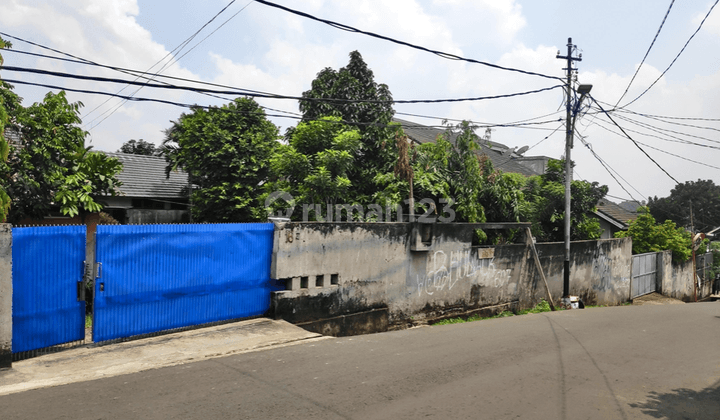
300,51 -> 398,201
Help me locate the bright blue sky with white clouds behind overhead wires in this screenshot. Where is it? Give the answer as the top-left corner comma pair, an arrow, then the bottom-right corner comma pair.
0,0 -> 720,202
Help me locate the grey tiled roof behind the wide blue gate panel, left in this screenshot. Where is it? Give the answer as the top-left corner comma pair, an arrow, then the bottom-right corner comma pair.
105,152 -> 188,198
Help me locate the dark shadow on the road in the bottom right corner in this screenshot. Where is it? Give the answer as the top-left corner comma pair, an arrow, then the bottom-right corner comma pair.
630,381 -> 720,420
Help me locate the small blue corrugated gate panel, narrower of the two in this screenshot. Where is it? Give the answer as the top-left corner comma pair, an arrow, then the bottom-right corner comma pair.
12,226 -> 86,353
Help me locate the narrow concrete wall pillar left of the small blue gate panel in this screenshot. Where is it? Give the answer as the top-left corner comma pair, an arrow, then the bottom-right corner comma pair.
0,223 -> 12,368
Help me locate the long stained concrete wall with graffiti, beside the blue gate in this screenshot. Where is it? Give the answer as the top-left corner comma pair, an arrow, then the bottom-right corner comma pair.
271,223 -> 631,335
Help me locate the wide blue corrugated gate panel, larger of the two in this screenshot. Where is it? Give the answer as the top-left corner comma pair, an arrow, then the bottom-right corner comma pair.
93,223 -> 274,342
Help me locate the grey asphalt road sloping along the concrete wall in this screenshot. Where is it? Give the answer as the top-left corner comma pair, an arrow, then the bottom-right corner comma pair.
0,302 -> 720,420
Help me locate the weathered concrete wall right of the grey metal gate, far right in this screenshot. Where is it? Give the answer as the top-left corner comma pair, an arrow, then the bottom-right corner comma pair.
658,251 -> 714,302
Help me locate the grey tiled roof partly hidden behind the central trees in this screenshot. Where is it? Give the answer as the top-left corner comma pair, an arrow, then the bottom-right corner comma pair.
393,118 -> 540,176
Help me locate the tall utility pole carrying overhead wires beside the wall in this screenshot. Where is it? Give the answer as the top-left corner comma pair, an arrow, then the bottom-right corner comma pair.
556,38 -> 582,298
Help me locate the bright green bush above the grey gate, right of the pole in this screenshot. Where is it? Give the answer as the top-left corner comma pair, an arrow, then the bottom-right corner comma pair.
615,207 -> 692,262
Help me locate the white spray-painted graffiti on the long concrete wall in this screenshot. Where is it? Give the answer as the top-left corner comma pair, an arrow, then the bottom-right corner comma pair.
417,249 -> 512,296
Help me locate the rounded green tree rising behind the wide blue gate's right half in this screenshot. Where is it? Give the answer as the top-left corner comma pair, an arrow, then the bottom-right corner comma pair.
162,98 -> 279,222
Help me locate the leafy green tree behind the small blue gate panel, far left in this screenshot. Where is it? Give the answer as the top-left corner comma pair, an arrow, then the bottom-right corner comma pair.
0,86 -> 122,222
